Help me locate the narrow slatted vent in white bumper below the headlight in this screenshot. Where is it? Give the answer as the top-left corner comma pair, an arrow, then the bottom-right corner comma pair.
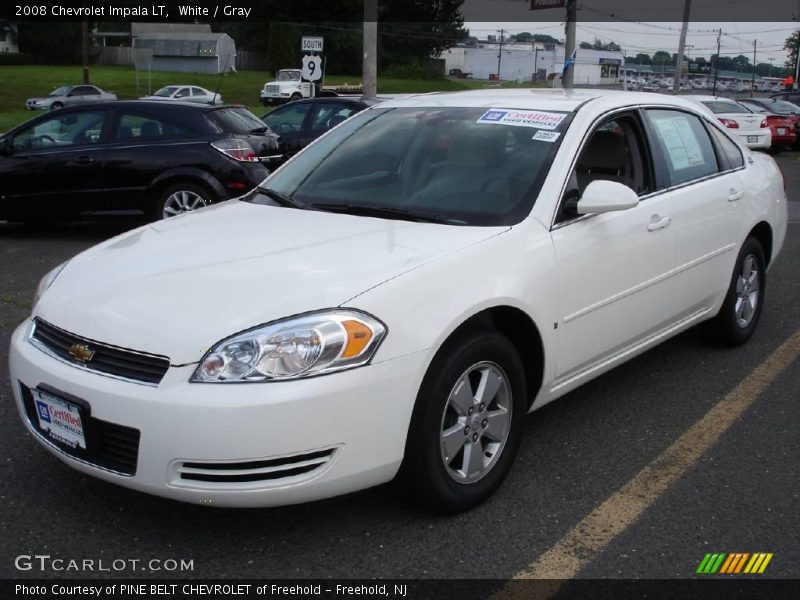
178,448 -> 334,483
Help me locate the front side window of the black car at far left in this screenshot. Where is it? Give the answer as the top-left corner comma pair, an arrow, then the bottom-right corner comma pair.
11,110 -> 106,152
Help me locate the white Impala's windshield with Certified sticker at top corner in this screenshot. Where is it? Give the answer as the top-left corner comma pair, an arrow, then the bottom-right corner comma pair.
249,107 -> 570,226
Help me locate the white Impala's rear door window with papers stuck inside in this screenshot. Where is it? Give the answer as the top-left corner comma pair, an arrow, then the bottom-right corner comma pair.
647,109 -> 719,185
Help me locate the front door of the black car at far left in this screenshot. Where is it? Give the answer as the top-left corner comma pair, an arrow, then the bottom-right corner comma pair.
0,107 -> 108,216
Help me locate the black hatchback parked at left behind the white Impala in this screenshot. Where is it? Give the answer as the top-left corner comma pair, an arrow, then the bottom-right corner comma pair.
0,101 -> 283,221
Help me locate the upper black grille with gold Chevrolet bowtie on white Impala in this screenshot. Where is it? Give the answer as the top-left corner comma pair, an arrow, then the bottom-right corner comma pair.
31,319 -> 169,384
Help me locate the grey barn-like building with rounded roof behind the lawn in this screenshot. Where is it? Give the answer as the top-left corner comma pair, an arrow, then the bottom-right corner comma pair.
131,23 -> 236,73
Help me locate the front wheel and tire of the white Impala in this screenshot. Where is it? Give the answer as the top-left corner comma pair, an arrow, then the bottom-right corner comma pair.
397,329 -> 527,512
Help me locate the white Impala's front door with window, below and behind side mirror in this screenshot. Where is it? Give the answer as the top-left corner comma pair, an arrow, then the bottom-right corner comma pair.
551,111 -> 675,389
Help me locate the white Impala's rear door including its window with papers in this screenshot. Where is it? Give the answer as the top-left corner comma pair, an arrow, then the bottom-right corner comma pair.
645,108 -> 745,319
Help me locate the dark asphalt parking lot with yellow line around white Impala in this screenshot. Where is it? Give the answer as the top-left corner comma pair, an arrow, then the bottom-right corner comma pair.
0,152 -> 800,580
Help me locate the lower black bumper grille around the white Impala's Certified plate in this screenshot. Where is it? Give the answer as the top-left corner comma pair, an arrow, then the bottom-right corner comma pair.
19,382 -> 140,476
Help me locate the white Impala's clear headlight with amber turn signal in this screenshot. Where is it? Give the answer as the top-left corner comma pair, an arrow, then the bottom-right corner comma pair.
191,310 -> 386,383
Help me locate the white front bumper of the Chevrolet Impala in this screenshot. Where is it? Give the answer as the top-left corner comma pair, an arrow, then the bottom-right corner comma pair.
10,321 -> 427,507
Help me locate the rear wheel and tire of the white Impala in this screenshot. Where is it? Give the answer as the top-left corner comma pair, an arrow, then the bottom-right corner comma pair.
711,237 -> 767,346
